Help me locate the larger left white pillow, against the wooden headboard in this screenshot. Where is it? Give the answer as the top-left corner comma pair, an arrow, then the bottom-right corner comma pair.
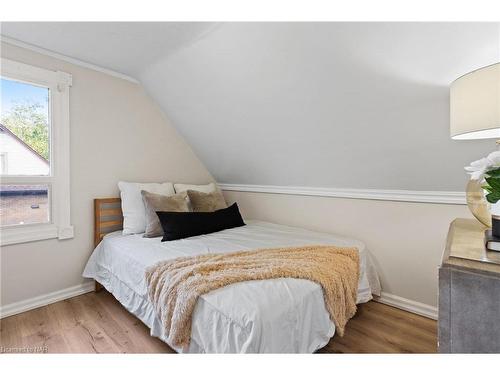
118,181 -> 175,234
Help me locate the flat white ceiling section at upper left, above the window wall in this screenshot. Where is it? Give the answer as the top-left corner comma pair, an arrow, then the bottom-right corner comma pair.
1,22 -> 216,78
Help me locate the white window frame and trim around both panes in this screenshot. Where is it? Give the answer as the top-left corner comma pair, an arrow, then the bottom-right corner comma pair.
0,58 -> 74,246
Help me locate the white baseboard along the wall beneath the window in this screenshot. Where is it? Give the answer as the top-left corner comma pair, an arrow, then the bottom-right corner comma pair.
0,281 -> 94,319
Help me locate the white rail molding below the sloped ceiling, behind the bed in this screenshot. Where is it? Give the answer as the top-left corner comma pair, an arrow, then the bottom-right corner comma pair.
219,183 -> 466,204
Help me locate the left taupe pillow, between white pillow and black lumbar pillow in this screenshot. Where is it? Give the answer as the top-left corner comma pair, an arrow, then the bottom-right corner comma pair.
141,190 -> 190,238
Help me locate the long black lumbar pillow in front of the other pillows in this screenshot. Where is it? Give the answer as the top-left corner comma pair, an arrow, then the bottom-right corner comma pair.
156,203 -> 245,242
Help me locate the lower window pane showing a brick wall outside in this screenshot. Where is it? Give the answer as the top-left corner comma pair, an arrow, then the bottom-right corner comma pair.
0,185 -> 50,227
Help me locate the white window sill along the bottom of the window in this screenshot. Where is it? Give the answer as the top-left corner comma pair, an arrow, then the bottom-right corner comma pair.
0,224 -> 73,246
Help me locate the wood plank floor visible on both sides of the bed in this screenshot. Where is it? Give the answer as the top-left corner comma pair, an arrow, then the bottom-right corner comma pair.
0,291 -> 437,353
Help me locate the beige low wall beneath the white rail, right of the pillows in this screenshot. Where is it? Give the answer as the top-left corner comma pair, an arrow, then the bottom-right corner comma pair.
224,191 -> 470,306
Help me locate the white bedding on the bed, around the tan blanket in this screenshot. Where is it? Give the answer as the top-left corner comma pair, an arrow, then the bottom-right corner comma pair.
83,221 -> 380,353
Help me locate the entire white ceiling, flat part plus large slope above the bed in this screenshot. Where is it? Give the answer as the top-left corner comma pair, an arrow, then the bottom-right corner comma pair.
2,23 -> 500,190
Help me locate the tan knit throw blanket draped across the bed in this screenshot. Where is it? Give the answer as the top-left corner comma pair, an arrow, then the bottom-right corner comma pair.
146,246 -> 359,348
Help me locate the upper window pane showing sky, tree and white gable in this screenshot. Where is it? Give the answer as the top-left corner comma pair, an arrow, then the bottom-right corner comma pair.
0,78 -> 50,176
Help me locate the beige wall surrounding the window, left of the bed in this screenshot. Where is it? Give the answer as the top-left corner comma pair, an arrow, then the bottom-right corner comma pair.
0,43 -> 212,306
